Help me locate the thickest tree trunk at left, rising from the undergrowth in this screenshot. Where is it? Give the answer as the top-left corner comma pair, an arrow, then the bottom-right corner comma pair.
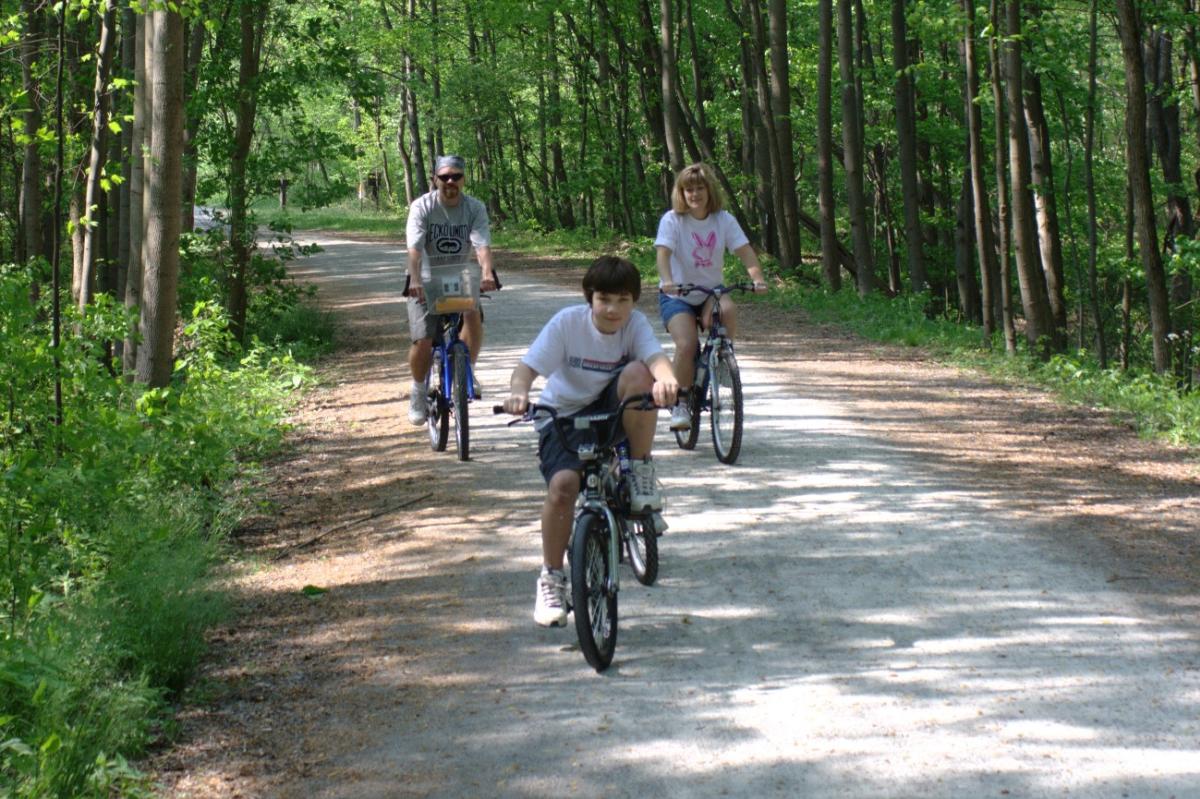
137,11 -> 184,388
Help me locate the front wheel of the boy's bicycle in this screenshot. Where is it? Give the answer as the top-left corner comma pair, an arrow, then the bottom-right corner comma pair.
570,511 -> 617,672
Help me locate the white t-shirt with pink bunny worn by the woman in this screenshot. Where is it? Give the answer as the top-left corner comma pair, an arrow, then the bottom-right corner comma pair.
654,211 -> 750,305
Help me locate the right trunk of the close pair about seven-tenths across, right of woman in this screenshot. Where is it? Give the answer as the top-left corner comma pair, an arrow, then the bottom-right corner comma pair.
838,0 -> 875,296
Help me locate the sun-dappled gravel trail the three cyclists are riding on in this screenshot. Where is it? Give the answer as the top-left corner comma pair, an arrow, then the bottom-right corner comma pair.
151,233 -> 1200,799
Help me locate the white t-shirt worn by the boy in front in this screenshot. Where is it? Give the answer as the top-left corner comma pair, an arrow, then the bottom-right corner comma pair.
521,305 -> 662,415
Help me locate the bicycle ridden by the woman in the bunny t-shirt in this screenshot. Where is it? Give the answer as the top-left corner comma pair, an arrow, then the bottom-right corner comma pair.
674,283 -> 754,463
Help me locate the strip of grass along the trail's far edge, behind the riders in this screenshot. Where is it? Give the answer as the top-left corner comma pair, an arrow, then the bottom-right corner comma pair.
267,206 -> 1200,446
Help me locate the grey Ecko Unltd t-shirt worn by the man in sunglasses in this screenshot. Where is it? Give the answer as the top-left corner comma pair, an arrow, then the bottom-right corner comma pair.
406,191 -> 492,281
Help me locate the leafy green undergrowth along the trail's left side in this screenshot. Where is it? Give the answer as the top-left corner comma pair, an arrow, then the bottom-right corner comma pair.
0,245 -> 331,799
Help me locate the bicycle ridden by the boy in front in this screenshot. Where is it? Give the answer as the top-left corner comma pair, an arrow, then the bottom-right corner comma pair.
492,394 -> 666,672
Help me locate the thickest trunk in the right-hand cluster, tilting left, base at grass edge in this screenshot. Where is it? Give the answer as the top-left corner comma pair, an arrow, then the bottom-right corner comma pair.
1004,0 -> 1054,358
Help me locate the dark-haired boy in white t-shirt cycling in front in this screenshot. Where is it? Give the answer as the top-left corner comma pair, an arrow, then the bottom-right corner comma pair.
504,256 -> 679,626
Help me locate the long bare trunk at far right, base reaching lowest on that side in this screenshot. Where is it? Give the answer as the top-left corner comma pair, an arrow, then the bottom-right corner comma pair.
1116,0 -> 1171,372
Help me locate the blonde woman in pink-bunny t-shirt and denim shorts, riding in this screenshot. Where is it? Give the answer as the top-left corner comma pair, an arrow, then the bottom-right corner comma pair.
654,163 -> 767,431
